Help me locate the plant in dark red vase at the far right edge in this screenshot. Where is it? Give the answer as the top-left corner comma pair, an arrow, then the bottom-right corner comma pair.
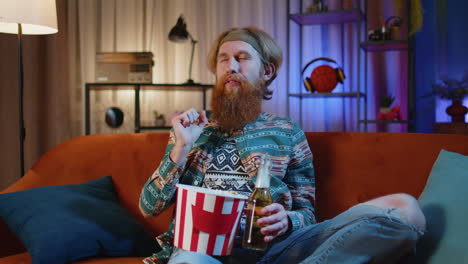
432,71 -> 468,123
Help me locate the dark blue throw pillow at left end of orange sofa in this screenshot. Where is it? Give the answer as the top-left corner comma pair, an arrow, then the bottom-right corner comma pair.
0,176 -> 158,264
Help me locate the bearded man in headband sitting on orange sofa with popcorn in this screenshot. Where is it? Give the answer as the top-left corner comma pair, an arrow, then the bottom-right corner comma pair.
140,27 -> 425,264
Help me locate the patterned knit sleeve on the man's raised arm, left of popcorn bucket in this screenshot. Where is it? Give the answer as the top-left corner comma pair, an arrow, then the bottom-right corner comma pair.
140,130 -> 183,216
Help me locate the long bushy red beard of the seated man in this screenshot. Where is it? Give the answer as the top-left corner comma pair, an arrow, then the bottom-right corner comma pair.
211,74 -> 265,131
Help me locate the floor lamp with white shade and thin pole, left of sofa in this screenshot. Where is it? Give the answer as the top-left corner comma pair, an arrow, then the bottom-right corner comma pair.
0,0 -> 58,176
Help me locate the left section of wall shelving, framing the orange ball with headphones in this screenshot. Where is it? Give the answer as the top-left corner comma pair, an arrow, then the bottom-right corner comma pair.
288,1 -> 366,130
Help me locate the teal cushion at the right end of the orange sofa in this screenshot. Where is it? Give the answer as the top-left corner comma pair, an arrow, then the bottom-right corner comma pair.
416,150 -> 468,264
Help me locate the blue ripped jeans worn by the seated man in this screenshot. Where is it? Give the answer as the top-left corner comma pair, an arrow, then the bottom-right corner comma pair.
169,204 -> 423,264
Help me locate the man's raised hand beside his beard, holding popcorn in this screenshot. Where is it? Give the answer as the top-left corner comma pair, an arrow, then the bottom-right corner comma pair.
170,108 -> 208,166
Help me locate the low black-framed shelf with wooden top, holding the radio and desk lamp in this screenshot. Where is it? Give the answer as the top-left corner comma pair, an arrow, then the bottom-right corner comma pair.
85,83 -> 213,135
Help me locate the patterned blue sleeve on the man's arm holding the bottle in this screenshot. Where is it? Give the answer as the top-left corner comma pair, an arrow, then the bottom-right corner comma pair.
284,124 -> 316,230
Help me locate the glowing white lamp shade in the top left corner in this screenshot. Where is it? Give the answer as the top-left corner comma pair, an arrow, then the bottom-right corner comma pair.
0,0 -> 58,35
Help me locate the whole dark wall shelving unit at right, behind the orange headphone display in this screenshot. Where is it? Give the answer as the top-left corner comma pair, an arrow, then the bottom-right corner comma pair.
288,0 -> 413,132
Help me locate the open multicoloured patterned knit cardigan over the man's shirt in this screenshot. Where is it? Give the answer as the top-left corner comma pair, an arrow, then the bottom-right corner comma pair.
140,113 -> 316,264
